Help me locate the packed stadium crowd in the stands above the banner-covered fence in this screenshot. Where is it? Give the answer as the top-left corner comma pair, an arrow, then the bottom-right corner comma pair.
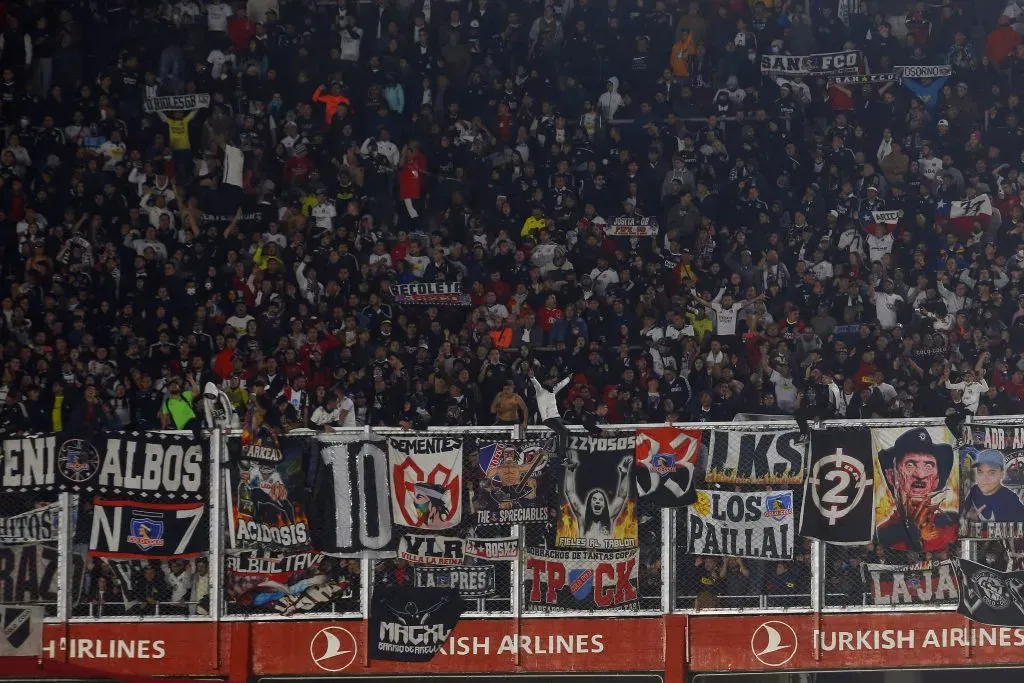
0,0 -> 1024,432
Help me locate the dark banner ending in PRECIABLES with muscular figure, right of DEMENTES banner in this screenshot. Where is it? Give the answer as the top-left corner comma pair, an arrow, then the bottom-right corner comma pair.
476,439 -> 553,524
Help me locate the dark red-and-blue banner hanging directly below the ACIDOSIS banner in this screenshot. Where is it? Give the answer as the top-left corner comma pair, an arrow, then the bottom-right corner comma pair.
224,550 -> 358,616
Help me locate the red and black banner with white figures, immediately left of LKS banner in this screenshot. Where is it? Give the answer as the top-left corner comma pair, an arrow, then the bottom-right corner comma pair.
634,427 -> 700,508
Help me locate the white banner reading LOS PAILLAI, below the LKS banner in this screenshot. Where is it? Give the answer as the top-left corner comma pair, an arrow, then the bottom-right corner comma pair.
686,490 -> 796,560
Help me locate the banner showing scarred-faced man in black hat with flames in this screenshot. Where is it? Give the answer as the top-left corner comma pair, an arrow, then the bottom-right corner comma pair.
871,427 -> 959,552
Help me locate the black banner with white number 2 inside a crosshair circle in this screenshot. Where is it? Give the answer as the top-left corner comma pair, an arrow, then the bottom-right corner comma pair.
800,429 -> 874,546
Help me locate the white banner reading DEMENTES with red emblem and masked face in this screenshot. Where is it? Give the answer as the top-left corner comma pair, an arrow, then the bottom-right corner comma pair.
388,436 -> 462,529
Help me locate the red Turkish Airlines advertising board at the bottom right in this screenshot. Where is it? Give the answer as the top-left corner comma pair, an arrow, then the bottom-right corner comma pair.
687,612 -> 1024,672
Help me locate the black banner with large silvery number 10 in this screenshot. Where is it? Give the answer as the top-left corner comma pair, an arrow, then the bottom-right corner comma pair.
311,440 -> 398,558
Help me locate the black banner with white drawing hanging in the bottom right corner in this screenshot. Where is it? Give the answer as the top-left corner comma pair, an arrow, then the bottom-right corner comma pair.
952,560 -> 1024,627
